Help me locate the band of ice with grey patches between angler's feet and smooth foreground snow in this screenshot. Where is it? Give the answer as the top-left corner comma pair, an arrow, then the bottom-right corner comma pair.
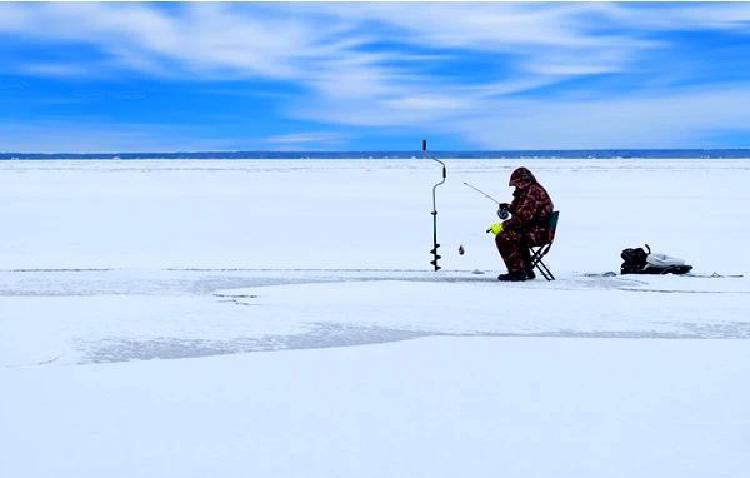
0,269 -> 750,365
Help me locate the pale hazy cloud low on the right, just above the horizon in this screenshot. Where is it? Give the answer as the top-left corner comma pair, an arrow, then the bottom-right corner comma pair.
458,85 -> 750,149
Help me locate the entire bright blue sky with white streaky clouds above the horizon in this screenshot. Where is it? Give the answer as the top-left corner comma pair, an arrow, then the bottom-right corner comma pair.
0,2 -> 750,152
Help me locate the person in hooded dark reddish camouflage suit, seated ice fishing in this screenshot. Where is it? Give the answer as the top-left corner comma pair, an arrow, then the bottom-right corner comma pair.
495,168 -> 554,282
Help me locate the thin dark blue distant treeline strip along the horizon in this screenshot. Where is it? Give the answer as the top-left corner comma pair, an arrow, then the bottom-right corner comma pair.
0,149 -> 750,160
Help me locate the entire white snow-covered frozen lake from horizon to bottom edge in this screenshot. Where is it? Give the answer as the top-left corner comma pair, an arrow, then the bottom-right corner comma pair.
0,160 -> 750,478
